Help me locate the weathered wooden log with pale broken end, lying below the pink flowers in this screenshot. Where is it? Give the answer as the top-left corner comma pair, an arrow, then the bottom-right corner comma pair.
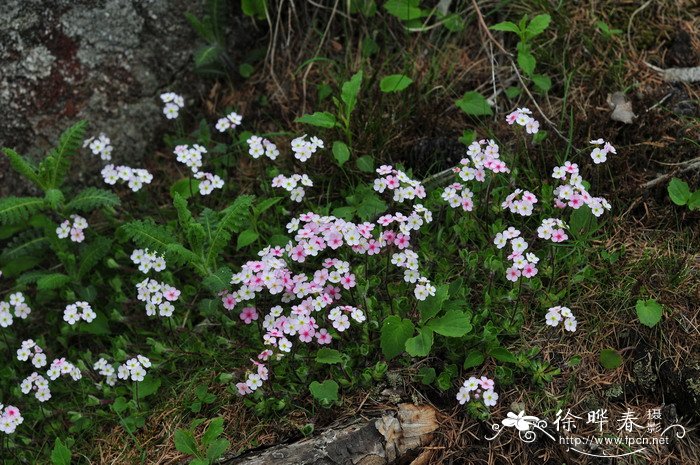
223,404 -> 438,465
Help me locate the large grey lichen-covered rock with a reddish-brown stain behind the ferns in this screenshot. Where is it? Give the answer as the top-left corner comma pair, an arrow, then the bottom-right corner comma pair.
0,0 -> 203,195
